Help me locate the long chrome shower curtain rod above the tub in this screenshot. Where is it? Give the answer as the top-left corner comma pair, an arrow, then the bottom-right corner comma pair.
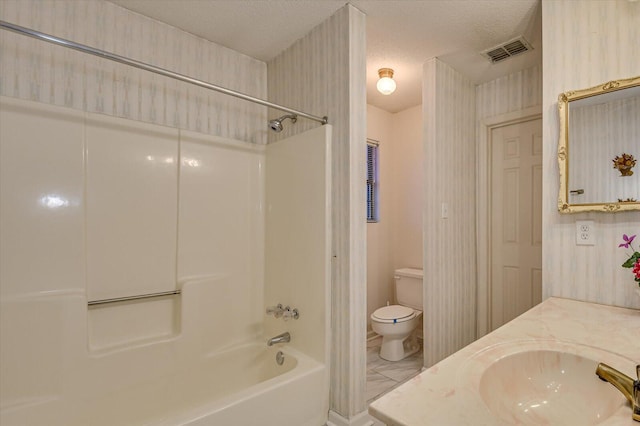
0,20 -> 329,124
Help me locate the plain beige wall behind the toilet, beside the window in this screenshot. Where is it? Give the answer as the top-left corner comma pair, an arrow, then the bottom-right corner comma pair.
367,105 -> 423,325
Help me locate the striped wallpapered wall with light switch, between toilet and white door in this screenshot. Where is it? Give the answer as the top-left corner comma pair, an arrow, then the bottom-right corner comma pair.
422,59 -> 476,367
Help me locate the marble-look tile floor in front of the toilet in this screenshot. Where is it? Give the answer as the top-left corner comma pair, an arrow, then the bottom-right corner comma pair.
366,336 -> 423,404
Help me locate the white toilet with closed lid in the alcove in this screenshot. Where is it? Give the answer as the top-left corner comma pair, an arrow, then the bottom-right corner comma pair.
371,268 -> 423,361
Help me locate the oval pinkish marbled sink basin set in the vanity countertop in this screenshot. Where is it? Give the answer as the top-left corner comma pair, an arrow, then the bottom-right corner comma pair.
478,350 -> 626,425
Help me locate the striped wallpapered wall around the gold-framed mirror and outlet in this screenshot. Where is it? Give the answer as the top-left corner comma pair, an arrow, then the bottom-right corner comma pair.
542,0 -> 640,308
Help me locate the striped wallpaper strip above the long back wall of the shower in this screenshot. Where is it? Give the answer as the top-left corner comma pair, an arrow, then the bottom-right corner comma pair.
0,0 -> 267,143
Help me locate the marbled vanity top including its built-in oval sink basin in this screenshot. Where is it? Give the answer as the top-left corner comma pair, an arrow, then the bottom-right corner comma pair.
369,297 -> 640,426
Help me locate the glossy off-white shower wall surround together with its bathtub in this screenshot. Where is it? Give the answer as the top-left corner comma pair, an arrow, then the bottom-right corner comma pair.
0,97 -> 331,426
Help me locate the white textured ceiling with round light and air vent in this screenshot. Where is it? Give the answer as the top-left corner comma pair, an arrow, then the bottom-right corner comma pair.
111,0 -> 542,112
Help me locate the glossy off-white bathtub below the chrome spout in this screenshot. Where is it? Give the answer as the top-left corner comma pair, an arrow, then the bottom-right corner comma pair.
1,342 -> 329,426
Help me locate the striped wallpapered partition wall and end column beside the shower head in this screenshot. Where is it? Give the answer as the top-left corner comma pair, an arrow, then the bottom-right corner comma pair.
268,5 -> 370,425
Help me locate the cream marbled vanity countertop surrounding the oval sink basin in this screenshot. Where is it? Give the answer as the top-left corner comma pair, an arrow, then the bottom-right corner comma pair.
369,298 -> 640,426
